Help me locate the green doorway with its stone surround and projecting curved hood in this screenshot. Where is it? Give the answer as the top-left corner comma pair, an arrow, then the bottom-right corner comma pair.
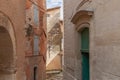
71,9 -> 94,80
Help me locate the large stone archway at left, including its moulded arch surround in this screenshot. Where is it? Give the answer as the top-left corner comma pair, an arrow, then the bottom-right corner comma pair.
0,12 -> 16,80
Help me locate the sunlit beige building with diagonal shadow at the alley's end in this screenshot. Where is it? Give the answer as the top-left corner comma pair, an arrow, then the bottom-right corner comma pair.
46,7 -> 63,73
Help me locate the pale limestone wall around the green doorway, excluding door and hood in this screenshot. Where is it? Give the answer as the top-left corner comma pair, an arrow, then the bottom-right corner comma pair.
64,0 -> 120,80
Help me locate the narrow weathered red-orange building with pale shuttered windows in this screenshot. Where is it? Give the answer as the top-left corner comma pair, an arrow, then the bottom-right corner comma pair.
25,0 -> 46,80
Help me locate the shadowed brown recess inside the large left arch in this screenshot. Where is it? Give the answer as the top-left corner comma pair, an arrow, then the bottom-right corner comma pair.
0,26 -> 13,80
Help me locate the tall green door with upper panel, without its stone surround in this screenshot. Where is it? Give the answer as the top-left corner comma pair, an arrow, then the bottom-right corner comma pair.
81,28 -> 90,80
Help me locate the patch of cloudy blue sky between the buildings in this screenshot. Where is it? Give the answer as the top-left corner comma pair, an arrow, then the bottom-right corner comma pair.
47,0 -> 62,8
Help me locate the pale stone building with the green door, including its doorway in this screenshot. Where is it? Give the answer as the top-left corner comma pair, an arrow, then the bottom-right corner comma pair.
63,0 -> 120,80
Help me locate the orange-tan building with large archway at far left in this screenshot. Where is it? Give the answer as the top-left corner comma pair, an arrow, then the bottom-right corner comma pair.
0,0 -> 26,80
